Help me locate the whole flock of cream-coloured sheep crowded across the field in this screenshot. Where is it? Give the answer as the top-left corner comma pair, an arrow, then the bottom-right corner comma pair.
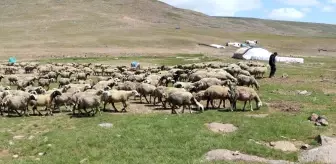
0,61 -> 267,116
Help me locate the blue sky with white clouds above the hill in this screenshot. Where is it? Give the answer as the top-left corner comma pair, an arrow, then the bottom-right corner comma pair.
160,0 -> 336,24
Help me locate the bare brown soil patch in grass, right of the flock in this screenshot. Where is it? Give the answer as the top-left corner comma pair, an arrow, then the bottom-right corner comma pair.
269,101 -> 303,112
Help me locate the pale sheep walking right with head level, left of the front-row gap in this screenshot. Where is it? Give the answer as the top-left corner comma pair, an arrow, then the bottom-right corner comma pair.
101,90 -> 139,112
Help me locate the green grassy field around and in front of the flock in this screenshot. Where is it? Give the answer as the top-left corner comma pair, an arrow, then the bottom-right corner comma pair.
0,54 -> 336,164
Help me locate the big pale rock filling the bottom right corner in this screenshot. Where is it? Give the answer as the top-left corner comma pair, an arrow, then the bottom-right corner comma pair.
299,136 -> 336,164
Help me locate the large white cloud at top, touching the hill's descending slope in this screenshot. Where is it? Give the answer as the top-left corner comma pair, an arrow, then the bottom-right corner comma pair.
160,0 -> 262,16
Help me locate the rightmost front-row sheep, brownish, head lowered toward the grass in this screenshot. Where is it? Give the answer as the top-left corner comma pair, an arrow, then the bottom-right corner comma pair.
229,86 -> 262,111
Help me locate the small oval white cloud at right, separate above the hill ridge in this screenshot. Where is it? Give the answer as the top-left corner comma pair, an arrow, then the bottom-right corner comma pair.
269,8 -> 305,20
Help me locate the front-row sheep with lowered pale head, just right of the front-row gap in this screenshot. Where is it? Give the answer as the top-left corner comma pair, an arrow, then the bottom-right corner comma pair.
165,91 -> 204,114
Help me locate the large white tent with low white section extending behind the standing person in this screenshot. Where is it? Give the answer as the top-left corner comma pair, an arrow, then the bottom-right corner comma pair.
232,47 -> 304,63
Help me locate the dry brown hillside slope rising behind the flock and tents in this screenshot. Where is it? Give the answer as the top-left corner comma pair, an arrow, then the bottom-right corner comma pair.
0,0 -> 336,57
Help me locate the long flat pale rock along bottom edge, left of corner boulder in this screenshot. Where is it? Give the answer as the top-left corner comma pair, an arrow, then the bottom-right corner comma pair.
205,149 -> 292,164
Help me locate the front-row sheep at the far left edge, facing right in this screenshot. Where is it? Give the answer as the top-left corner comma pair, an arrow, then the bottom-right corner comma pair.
2,95 -> 36,116
